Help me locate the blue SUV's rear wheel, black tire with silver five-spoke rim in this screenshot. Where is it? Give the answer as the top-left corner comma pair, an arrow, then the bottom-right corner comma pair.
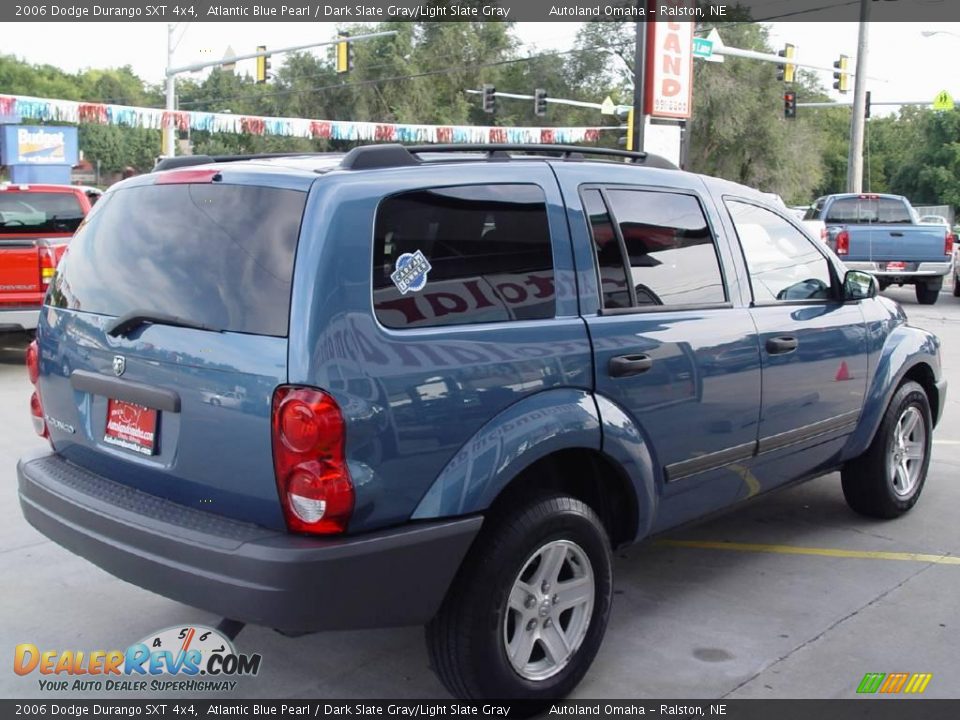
426,495 -> 612,700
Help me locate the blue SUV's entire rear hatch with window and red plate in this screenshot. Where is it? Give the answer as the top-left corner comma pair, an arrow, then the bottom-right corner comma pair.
38,170 -> 306,528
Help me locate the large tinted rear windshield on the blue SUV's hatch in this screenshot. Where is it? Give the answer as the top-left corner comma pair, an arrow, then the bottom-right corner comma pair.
49,184 -> 306,337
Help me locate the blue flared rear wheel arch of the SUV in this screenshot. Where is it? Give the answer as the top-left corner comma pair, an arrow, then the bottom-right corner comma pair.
412,389 -> 655,546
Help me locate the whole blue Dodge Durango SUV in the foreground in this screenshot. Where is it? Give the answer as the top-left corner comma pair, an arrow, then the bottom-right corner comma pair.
19,145 -> 946,699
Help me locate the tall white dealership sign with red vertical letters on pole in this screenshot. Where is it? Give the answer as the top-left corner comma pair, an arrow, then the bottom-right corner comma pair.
645,0 -> 694,120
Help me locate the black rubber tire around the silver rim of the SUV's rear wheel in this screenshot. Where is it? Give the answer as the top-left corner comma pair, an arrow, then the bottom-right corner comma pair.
426,495 -> 613,696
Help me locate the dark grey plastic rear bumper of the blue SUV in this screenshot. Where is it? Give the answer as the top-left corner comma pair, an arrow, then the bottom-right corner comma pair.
17,452 -> 483,632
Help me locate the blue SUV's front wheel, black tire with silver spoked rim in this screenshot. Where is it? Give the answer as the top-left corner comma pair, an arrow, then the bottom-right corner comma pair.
841,381 -> 933,518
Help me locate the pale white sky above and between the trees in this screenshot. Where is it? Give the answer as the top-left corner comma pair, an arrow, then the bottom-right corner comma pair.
0,22 -> 960,115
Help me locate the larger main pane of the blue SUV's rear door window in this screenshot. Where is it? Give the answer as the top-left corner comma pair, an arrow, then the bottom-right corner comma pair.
607,190 -> 726,306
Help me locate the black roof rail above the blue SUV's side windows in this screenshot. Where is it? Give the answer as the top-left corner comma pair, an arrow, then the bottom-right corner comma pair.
340,143 -> 679,170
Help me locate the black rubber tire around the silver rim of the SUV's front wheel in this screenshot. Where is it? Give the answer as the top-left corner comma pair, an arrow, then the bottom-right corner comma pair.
840,380 -> 933,519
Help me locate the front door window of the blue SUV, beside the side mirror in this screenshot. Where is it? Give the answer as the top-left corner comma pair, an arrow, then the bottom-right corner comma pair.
727,200 -> 832,302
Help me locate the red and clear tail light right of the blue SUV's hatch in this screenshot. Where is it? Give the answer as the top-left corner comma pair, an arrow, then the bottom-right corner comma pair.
273,385 -> 354,534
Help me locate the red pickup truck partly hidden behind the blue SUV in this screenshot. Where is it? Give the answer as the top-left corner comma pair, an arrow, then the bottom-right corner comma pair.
0,183 -> 90,332
